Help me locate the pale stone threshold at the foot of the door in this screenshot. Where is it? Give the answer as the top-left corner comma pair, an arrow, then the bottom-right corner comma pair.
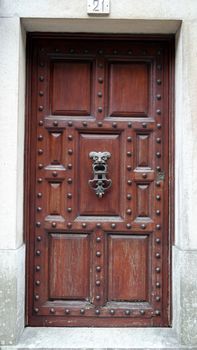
1,327 -> 197,350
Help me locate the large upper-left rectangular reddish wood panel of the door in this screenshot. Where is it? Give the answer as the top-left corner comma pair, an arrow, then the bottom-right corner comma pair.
51,61 -> 91,116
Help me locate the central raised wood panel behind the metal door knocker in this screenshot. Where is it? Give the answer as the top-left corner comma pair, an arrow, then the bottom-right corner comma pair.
77,133 -> 121,216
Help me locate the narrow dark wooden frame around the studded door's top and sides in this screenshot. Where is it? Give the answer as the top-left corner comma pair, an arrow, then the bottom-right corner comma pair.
24,33 -> 175,325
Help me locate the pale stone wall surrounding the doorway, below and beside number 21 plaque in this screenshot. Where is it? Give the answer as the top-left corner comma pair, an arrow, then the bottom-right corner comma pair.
0,0 -> 197,346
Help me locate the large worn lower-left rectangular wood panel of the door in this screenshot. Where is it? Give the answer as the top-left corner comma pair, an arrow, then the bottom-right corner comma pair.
49,233 -> 90,300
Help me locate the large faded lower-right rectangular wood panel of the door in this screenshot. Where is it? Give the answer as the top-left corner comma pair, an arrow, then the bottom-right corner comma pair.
108,235 -> 149,301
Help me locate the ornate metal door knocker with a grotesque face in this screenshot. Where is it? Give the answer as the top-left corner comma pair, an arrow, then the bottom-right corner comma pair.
88,152 -> 112,198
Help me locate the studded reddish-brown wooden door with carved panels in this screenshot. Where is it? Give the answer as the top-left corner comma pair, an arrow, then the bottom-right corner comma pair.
26,35 -> 174,326
